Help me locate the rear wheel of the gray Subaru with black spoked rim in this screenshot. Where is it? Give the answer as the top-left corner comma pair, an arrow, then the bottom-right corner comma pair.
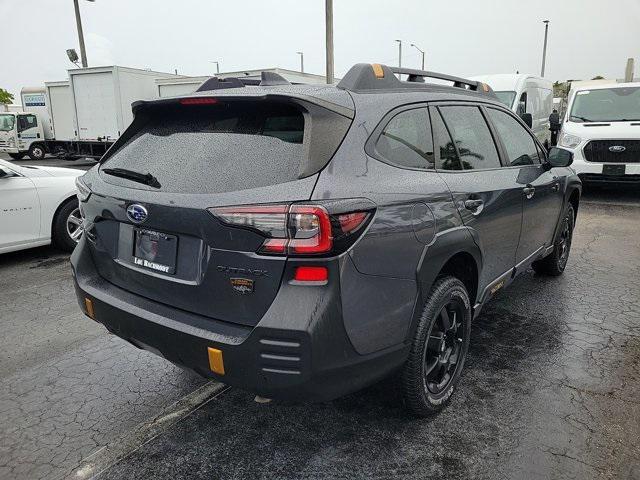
401,276 -> 471,417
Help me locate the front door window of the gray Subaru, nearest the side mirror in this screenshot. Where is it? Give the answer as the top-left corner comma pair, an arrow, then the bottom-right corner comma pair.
487,108 -> 539,166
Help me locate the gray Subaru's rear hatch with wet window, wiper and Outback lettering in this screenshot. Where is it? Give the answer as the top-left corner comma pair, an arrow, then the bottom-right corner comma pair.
83,95 -> 351,325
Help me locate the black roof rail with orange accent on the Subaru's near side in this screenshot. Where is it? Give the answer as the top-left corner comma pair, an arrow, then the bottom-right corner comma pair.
338,63 -> 495,95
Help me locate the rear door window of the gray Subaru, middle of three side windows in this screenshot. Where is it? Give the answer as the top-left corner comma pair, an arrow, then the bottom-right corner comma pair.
440,106 -> 501,170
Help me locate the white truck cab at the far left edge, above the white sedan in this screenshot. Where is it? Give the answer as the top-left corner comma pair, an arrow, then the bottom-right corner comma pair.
0,112 -> 46,160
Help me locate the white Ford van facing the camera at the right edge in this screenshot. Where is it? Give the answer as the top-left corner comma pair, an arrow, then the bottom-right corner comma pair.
558,82 -> 640,184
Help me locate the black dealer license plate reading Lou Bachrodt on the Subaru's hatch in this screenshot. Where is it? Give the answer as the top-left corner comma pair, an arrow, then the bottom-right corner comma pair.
133,229 -> 178,274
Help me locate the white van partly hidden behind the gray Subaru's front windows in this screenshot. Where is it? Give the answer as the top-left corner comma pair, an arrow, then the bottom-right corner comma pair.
471,73 -> 553,148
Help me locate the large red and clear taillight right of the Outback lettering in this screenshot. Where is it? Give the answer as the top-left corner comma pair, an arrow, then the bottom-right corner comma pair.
209,204 -> 371,256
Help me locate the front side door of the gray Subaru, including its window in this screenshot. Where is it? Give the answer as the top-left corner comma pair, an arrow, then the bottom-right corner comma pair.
486,107 -> 564,266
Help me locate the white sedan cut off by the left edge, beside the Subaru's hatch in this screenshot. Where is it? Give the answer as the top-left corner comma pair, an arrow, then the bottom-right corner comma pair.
0,160 -> 84,253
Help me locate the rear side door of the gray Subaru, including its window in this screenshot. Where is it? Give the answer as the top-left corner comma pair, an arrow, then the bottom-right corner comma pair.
431,104 -> 522,293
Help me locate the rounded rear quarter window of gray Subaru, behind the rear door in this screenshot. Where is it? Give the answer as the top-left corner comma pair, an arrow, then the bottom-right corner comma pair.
375,108 -> 434,168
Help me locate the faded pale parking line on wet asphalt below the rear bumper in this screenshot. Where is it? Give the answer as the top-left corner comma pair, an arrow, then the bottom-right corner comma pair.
59,381 -> 229,480
